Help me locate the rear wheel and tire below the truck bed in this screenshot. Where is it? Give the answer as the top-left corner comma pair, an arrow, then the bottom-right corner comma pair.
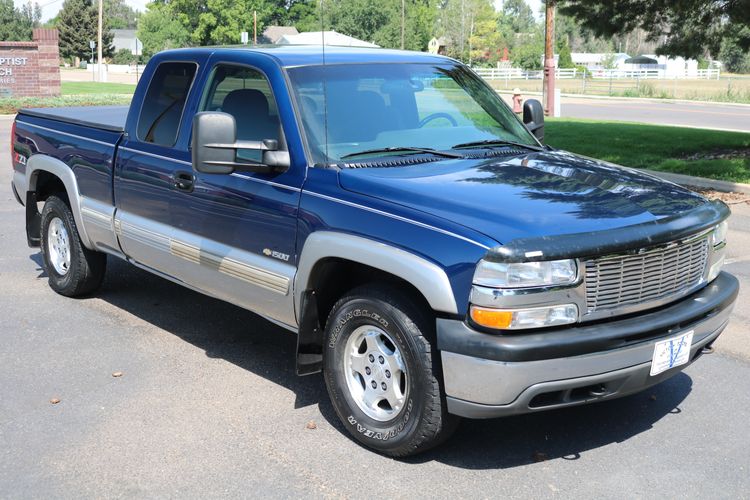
41,195 -> 107,297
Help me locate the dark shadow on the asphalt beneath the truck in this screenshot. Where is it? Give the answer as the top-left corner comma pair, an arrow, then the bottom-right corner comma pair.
88,257 -> 692,469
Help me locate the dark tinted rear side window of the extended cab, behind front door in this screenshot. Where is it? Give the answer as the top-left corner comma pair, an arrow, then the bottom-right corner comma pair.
137,62 -> 197,146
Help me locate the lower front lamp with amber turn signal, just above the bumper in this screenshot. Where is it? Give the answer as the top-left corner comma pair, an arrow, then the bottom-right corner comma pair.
470,304 -> 578,330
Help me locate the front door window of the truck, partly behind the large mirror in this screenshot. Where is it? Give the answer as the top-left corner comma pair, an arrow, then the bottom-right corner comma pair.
201,65 -> 279,161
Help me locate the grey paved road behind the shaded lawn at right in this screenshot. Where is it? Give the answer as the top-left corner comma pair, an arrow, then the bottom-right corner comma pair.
560,97 -> 750,132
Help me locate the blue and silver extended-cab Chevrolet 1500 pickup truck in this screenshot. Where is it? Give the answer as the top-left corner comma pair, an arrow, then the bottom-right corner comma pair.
11,47 -> 738,456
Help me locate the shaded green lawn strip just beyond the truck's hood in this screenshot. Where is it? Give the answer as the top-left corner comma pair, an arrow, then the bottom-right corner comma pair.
545,119 -> 750,183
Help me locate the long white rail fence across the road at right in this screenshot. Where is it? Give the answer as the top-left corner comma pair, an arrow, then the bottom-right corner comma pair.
472,68 -> 721,80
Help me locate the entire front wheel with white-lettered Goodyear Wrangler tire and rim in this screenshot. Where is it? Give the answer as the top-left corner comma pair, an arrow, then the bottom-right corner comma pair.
324,286 -> 457,457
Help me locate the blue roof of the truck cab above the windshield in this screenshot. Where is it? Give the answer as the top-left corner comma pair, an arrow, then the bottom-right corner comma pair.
166,45 -> 454,67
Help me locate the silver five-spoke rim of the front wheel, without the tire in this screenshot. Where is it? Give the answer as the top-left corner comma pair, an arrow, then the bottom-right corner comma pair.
343,325 -> 409,422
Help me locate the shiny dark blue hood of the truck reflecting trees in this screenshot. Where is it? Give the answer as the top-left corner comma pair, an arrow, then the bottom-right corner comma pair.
340,151 -> 706,243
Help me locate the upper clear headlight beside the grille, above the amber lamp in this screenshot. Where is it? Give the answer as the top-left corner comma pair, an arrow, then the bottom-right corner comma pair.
474,259 -> 578,288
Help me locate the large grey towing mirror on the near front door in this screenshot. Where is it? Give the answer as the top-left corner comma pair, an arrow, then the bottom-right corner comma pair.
192,111 -> 290,174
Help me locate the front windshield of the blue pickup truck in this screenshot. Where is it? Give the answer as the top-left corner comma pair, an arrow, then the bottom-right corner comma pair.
289,63 -> 539,163
